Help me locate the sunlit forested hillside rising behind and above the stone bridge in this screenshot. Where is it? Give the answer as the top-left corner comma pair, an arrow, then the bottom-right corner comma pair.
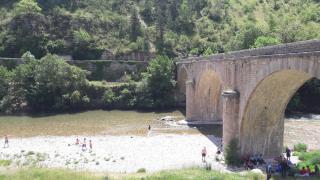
0,0 -> 320,59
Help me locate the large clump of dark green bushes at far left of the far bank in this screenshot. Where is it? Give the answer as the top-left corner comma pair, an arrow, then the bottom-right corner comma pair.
0,53 -> 87,112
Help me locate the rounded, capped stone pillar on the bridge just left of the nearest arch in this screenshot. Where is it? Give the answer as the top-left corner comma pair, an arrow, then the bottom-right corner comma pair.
222,90 -> 240,150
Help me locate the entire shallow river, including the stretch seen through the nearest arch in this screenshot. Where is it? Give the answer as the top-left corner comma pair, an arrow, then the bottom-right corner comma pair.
0,110 -> 320,149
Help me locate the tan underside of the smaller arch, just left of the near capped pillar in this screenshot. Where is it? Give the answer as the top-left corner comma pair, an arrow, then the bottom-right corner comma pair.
193,70 -> 222,122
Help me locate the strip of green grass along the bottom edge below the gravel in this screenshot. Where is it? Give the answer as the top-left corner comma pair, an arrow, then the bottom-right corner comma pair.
0,169 -> 265,180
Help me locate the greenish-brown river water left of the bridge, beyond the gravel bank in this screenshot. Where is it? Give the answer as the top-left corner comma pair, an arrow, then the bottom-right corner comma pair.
0,110 -> 221,137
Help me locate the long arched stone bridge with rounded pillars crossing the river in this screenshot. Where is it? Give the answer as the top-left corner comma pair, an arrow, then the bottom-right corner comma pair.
177,40 -> 320,157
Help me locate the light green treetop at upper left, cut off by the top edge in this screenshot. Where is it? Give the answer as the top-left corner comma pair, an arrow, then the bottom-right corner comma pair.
14,0 -> 42,15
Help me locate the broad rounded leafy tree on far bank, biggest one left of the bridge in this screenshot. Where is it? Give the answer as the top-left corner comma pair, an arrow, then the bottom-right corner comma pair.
23,52 -> 86,110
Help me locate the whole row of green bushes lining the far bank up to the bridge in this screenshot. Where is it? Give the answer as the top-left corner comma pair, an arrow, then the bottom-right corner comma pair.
0,52 -> 175,113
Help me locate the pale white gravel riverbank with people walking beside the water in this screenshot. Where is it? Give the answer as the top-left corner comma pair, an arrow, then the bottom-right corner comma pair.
0,134 -> 224,173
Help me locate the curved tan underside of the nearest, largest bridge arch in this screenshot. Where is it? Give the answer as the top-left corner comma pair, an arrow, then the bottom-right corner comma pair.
240,69 -> 314,156
